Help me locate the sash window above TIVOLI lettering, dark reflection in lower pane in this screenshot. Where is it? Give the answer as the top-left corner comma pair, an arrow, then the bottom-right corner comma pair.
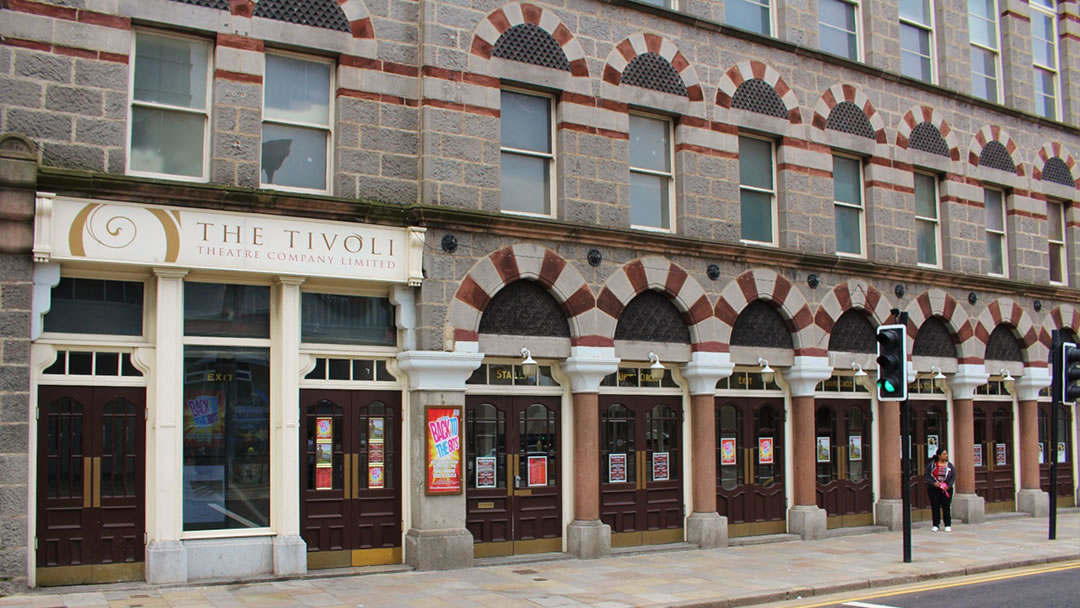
260,54 -> 333,192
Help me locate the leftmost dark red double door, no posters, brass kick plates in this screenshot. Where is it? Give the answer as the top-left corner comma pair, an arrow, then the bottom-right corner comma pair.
36,387 -> 146,585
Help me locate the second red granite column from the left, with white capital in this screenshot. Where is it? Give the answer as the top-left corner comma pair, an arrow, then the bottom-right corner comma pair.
683,352 -> 734,549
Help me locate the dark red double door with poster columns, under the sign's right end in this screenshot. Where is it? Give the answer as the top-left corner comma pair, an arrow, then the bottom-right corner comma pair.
300,389 -> 402,569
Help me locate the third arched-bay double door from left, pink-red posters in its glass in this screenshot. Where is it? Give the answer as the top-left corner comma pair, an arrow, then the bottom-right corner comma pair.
716,397 -> 786,537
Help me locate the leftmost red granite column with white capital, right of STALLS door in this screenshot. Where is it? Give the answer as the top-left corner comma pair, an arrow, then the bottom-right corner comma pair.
563,347 -> 619,559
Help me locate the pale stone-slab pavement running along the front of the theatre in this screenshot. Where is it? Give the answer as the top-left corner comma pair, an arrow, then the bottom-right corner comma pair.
6,509 -> 1080,608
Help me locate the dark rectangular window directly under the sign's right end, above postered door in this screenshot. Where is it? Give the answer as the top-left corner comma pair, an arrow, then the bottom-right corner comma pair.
300,293 -> 397,347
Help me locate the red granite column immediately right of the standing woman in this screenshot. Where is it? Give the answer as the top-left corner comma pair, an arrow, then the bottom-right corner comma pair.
949,364 -> 989,524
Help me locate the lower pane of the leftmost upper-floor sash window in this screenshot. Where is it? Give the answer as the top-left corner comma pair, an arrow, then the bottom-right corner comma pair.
131,107 -> 206,177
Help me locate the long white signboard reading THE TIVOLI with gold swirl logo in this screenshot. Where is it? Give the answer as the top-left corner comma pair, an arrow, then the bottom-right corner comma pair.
33,195 -> 424,285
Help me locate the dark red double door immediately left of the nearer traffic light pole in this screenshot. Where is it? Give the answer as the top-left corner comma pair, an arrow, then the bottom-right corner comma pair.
814,400 -> 874,528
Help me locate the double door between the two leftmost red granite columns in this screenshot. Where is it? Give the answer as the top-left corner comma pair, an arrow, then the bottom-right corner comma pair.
599,395 -> 685,546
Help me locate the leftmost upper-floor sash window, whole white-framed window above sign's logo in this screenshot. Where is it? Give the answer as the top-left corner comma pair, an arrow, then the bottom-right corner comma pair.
127,31 -> 211,180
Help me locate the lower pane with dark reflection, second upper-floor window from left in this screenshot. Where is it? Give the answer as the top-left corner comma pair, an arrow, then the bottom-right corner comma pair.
261,123 -> 326,190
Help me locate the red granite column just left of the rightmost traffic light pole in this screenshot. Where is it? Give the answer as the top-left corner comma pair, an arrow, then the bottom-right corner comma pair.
1016,367 -> 1055,517
